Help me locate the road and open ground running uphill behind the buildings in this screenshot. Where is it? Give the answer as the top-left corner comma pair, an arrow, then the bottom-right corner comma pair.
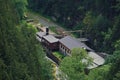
27,12 -> 69,35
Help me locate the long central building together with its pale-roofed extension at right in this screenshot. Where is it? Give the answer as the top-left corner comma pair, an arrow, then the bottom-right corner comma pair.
59,36 -> 105,69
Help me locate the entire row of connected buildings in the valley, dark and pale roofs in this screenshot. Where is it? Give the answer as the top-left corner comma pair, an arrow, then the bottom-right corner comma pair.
36,32 -> 105,69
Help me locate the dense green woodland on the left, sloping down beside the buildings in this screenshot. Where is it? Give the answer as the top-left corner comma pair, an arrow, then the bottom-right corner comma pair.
0,0 -> 53,80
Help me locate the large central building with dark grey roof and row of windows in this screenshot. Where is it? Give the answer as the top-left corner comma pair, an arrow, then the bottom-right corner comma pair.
59,36 -> 93,55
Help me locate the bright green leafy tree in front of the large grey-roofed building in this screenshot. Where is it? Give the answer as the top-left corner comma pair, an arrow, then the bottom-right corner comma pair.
60,48 -> 92,80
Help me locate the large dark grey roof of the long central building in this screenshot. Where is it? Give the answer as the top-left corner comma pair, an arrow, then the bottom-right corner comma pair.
59,36 -> 93,51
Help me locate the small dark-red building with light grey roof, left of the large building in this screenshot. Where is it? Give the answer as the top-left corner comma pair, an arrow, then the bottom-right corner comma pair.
41,35 -> 59,51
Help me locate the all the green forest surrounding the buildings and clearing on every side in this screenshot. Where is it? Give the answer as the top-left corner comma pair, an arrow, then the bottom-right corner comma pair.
0,0 -> 120,80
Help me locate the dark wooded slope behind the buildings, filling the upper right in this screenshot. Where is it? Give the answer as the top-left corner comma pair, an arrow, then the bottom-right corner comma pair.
28,0 -> 120,54
